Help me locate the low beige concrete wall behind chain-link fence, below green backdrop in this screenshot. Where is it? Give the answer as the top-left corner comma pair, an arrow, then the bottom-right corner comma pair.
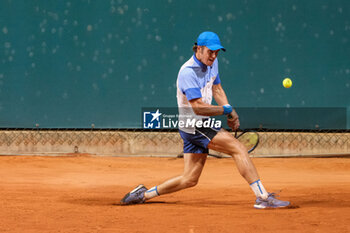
0,130 -> 350,157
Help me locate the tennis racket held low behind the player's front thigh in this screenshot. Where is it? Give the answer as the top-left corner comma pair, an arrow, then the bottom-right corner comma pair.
209,130 -> 259,158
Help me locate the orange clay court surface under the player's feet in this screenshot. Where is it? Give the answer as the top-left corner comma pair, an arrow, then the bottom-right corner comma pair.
0,156 -> 350,233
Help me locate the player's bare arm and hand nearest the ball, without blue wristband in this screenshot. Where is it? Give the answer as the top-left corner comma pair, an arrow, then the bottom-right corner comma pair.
213,83 -> 240,130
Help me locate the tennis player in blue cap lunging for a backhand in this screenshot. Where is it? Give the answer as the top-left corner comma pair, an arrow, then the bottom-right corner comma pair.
121,31 -> 290,209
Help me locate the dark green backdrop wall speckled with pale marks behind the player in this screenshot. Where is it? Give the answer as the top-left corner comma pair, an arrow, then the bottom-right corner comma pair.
0,0 -> 350,128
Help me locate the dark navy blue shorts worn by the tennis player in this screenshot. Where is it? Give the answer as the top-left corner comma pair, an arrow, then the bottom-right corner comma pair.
179,128 -> 220,154
